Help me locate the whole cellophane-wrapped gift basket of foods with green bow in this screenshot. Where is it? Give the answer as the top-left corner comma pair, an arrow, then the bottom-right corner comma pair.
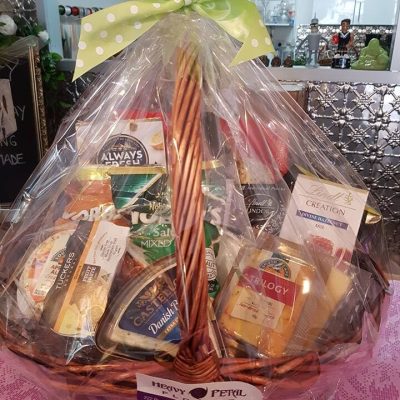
0,1 -> 390,400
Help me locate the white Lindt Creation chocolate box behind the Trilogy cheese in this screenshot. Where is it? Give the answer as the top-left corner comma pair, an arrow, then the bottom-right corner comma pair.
279,175 -> 369,255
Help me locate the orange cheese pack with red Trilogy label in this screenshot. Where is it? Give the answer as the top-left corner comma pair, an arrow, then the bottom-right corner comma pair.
220,245 -> 317,357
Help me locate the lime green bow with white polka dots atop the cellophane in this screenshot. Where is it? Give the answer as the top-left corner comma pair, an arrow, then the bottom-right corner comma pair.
74,0 -> 274,79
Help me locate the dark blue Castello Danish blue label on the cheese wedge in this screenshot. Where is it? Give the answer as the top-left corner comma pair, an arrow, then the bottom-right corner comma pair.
119,268 -> 180,343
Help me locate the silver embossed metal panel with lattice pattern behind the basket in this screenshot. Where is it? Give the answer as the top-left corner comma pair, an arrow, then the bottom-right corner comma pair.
308,82 -> 400,253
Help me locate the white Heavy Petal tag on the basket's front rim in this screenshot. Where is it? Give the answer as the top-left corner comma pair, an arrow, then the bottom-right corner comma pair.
136,374 -> 262,400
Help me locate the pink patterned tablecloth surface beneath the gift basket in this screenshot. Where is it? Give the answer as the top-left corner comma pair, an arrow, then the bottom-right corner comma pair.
0,282 -> 400,400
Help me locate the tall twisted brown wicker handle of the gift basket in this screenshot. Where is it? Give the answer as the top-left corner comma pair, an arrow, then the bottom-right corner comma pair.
169,45 -> 220,383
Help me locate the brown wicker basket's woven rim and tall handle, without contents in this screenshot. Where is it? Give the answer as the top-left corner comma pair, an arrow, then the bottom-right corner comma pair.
0,47 -> 386,396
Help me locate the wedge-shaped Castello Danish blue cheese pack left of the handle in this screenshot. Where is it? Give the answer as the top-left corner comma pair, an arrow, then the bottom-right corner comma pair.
96,258 -> 181,359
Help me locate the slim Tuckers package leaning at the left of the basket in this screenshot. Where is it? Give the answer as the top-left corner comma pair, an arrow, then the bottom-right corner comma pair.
41,221 -> 128,337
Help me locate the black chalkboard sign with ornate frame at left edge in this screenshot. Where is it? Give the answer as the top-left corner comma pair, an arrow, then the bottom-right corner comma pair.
0,47 -> 47,206
